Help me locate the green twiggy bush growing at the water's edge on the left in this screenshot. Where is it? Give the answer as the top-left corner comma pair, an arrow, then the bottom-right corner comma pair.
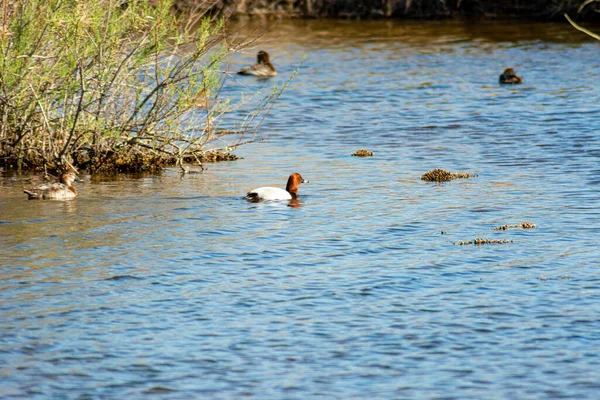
0,0 -> 290,173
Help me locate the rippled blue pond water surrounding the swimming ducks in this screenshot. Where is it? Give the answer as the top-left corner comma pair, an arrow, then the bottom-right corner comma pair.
0,21 -> 600,399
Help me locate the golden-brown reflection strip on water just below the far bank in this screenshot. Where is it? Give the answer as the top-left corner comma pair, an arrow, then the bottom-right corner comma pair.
229,20 -> 594,50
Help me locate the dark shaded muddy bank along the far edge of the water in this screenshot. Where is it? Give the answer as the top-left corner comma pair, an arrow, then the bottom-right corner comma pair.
183,0 -> 600,21
